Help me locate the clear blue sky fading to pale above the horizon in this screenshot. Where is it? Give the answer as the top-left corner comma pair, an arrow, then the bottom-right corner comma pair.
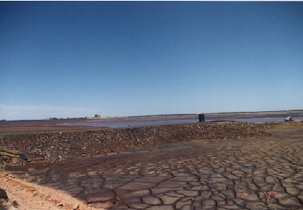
0,2 -> 303,119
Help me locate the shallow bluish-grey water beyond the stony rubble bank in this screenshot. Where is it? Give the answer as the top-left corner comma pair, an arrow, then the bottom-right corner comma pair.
60,117 -> 303,128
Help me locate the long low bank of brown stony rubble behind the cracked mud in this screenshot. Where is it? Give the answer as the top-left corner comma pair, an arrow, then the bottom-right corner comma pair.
0,123 -> 273,164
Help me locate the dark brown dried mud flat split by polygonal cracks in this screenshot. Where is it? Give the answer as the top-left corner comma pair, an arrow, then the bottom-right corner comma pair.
5,128 -> 303,210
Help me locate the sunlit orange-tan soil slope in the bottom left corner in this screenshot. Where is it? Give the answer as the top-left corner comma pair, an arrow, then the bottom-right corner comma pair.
0,173 -> 98,210
